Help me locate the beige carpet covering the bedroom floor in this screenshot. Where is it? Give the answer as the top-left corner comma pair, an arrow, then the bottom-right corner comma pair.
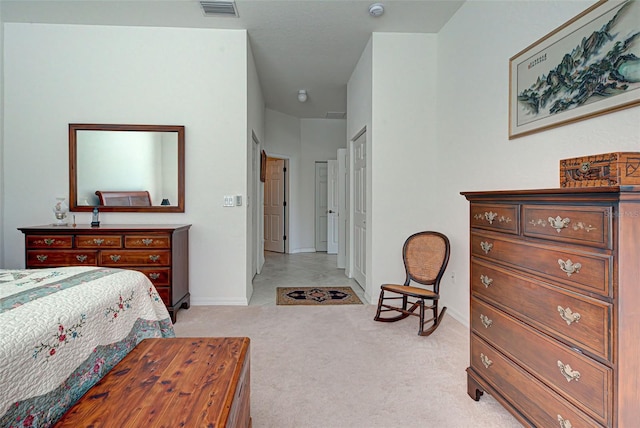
175,304 -> 520,428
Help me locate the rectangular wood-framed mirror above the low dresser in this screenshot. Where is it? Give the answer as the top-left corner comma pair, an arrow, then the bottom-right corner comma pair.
69,123 -> 184,212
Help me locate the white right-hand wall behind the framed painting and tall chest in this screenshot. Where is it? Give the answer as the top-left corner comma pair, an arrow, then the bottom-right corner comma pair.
436,1 -> 640,323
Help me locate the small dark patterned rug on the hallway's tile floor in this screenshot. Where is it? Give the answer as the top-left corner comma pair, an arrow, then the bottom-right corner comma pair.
276,287 -> 362,305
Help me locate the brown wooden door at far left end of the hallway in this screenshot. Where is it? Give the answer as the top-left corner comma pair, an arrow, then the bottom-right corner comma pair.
264,158 -> 285,253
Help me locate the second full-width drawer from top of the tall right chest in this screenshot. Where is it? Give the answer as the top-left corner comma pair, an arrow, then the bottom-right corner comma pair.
471,259 -> 613,361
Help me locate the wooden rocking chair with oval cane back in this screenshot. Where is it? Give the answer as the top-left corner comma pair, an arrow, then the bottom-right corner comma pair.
374,231 -> 449,336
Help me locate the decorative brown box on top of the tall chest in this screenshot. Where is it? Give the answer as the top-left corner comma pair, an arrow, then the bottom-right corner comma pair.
560,152 -> 640,187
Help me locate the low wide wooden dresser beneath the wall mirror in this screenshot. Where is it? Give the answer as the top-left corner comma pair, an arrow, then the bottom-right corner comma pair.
18,224 -> 191,322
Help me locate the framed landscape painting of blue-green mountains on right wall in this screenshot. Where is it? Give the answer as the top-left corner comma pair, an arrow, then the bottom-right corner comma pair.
509,0 -> 640,139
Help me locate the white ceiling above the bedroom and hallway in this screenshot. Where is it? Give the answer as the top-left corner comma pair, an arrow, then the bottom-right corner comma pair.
0,0 -> 464,118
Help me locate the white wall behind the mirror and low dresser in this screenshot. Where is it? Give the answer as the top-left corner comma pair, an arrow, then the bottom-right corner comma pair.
3,23 -> 255,304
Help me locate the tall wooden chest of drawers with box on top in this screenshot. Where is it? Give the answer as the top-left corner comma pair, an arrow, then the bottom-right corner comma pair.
462,186 -> 640,428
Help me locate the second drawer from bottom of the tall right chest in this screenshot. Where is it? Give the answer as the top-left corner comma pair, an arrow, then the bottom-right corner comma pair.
471,299 -> 613,425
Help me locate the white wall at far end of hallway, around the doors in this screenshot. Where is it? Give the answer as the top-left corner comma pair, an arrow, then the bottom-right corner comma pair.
265,109 -> 346,253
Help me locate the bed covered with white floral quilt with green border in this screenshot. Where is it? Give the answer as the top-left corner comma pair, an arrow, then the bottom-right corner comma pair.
0,266 -> 175,427
